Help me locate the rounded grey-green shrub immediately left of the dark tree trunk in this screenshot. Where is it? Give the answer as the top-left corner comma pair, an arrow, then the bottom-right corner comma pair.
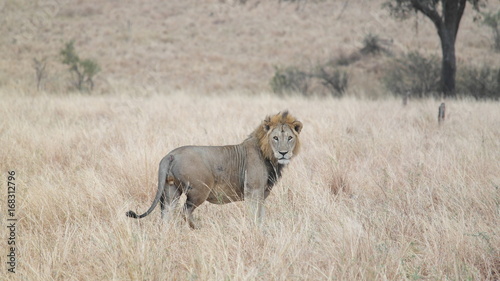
383,52 -> 441,97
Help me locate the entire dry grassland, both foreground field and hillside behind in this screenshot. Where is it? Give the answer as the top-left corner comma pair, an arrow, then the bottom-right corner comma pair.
0,0 -> 500,280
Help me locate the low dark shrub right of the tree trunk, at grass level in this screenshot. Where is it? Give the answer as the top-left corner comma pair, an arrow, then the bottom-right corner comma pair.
457,66 -> 500,100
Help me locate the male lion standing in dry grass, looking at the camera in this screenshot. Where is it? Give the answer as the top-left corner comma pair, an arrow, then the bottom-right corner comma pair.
126,111 -> 302,228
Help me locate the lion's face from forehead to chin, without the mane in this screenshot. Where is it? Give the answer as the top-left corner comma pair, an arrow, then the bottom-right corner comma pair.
269,125 -> 298,164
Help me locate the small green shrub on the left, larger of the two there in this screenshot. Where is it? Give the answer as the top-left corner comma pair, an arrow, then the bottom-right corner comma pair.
61,40 -> 100,91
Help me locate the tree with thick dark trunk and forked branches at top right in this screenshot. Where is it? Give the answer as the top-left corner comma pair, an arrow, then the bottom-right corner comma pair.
384,0 -> 481,97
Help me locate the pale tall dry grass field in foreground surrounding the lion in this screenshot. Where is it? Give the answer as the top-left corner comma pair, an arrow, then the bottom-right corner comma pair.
0,91 -> 500,280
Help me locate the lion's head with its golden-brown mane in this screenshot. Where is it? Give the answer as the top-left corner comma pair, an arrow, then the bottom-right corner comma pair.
254,111 -> 302,164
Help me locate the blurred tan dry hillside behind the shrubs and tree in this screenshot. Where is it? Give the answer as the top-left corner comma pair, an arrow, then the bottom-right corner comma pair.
0,0 -> 500,96
